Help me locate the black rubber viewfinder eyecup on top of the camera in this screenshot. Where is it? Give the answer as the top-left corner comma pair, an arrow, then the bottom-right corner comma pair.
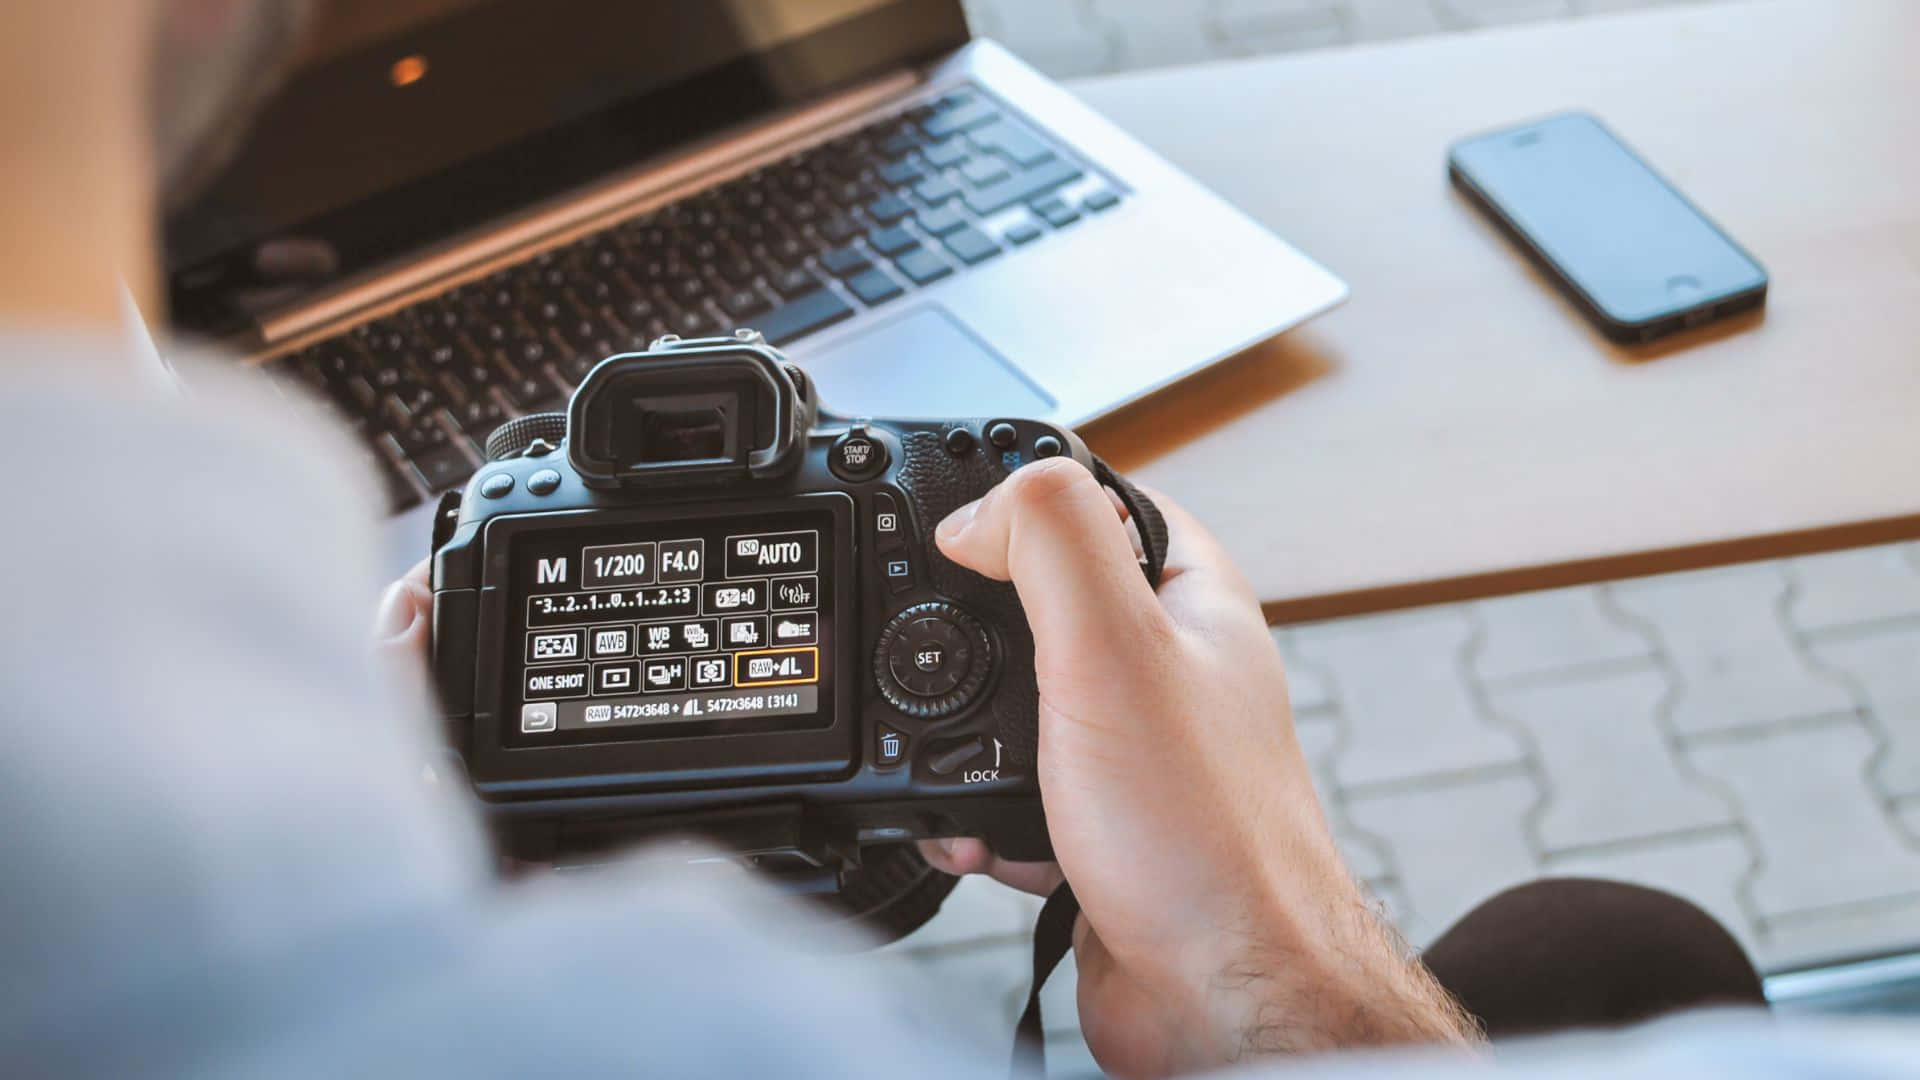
566,332 -> 816,488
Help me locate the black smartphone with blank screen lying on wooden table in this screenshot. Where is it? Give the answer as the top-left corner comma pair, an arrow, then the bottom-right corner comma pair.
1448,111 -> 1766,344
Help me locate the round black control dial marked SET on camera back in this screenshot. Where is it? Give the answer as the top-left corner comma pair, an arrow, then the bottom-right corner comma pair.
874,603 -> 993,721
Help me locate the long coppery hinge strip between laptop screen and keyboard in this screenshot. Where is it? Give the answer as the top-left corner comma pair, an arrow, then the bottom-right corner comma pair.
257,69 -> 922,354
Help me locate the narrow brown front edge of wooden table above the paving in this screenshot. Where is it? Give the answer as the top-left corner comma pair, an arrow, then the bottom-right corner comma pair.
1261,513 -> 1920,626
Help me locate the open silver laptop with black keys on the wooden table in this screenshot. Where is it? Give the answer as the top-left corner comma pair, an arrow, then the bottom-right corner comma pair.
165,0 -> 1346,565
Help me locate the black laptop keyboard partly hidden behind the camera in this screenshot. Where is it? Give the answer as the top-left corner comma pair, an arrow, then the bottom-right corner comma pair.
271,88 -> 1119,513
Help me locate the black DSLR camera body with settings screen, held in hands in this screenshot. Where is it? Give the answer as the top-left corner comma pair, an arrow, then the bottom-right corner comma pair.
432,331 -> 1094,876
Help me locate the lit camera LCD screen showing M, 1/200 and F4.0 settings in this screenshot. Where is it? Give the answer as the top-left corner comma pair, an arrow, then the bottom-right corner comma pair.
503,509 -> 835,748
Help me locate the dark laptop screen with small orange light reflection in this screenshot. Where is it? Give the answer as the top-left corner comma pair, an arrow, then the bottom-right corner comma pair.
165,0 -> 966,336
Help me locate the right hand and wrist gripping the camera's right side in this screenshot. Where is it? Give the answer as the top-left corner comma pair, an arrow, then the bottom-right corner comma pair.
922,459 -> 1476,1076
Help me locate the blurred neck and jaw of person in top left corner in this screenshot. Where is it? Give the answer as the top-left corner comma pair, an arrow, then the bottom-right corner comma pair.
0,0 -> 317,323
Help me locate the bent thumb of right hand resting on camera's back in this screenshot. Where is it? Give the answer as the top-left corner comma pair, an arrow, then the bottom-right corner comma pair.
935,457 -> 1169,657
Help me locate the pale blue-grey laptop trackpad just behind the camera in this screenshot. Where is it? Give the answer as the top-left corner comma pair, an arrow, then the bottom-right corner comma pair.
803,306 -> 1054,417
